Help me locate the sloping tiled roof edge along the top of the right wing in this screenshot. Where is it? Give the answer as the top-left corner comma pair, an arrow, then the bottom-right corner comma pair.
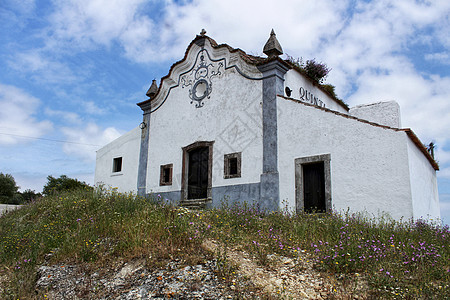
277,95 -> 439,171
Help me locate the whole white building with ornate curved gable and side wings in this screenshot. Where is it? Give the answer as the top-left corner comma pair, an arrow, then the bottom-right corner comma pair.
95,31 -> 440,219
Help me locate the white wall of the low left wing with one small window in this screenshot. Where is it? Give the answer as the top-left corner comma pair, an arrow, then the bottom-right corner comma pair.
94,127 -> 141,192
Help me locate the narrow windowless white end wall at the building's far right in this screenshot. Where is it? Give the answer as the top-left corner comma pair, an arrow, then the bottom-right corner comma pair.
408,139 -> 441,220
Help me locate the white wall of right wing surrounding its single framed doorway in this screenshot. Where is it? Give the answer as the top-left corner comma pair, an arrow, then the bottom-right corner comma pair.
278,98 -> 413,219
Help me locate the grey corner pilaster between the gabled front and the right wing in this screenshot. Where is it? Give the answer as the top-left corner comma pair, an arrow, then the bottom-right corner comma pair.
258,60 -> 288,211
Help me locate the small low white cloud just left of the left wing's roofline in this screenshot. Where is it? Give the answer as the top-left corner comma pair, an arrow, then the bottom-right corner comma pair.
61,123 -> 121,161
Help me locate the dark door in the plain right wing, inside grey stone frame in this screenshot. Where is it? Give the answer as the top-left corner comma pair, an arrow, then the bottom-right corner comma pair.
303,162 -> 326,213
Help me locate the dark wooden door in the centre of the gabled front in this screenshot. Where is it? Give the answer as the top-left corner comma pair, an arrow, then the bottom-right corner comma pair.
188,147 -> 209,199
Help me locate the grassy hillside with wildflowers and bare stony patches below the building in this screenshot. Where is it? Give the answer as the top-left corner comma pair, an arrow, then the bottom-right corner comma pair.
0,190 -> 450,299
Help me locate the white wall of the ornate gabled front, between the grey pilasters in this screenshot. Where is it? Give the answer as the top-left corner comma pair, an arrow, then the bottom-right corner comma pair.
147,45 -> 262,192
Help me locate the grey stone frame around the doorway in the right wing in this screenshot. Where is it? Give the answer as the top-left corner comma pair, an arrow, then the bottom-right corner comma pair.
295,154 -> 332,213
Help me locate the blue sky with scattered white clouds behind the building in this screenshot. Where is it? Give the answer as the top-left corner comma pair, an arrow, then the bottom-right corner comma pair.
0,0 -> 450,223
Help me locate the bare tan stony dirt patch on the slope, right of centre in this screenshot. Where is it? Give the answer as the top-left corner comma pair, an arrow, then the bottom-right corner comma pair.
202,240 -> 367,299
